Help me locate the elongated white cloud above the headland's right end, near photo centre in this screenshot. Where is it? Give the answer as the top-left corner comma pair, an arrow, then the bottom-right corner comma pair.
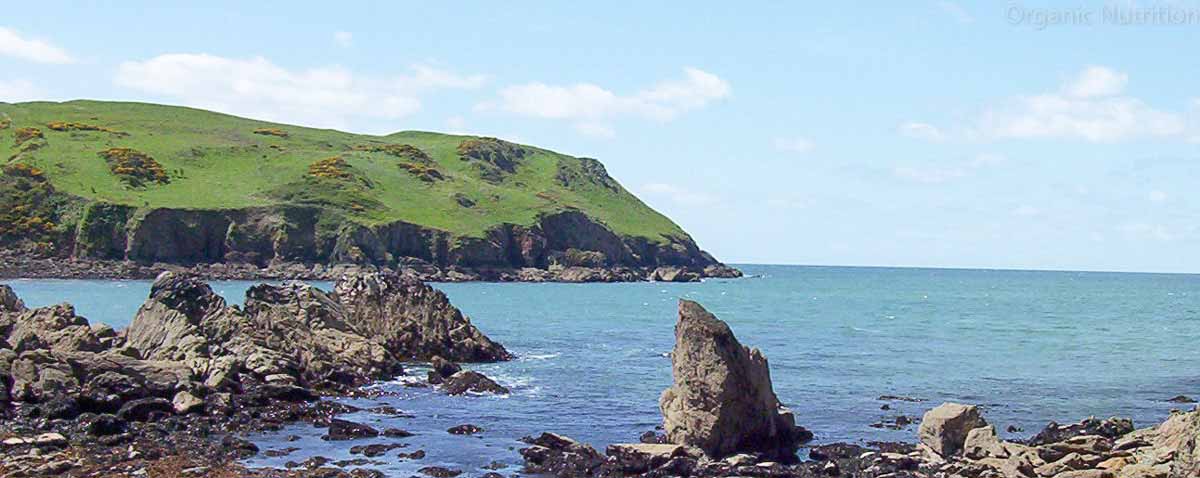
487,67 -> 731,132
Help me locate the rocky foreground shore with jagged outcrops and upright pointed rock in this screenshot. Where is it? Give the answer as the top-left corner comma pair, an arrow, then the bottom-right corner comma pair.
0,276 -> 1200,478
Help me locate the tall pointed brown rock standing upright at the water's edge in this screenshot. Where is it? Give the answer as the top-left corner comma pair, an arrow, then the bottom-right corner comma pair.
659,300 -> 806,461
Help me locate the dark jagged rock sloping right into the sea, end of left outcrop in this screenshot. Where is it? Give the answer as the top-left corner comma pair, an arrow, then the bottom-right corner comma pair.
334,273 -> 512,362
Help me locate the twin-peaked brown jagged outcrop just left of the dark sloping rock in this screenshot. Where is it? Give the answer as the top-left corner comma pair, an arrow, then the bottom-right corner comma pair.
127,273 -> 401,389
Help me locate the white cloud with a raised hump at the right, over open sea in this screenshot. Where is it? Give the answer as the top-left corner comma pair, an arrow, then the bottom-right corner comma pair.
977,66 -> 1188,143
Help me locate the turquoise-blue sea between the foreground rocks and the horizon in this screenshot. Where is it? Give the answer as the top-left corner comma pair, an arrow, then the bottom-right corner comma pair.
8,265 -> 1200,474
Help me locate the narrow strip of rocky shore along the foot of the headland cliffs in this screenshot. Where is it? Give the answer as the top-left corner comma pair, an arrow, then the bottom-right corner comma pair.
0,250 -> 742,283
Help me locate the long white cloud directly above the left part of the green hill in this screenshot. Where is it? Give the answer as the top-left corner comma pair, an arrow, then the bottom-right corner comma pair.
114,53 -> 484,127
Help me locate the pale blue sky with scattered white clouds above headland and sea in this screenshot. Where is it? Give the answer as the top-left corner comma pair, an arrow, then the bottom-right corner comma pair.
0,0 -> 1200,273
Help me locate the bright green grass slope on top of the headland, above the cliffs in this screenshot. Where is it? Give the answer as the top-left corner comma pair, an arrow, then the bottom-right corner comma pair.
0,101 -> 686,241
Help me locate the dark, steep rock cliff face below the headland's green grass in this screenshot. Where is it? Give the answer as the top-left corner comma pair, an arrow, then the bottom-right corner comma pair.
72,203 -> 720,271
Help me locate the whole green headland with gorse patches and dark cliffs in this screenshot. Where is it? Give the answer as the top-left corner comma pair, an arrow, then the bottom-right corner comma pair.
0,101 -> 714,272
